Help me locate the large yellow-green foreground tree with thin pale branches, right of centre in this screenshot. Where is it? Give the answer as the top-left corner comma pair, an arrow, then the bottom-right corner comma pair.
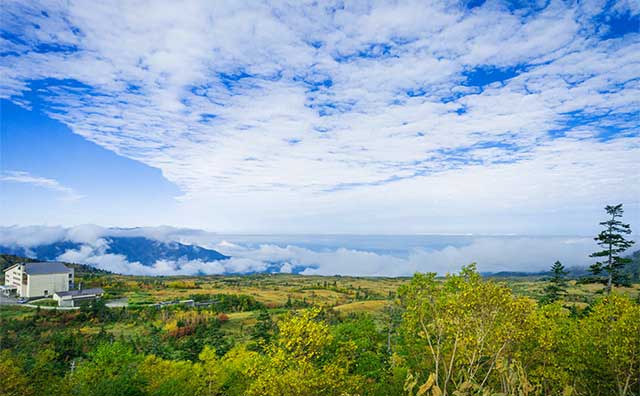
399,265 -> 535,395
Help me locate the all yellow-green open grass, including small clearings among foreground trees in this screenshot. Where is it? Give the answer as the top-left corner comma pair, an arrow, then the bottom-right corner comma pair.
0,274 -> 640,340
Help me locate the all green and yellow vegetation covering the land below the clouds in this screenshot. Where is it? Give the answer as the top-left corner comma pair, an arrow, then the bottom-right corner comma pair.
0,207 -> 640,396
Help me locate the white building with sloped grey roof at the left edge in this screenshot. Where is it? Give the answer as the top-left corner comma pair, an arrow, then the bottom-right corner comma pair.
4,262 -> 74,298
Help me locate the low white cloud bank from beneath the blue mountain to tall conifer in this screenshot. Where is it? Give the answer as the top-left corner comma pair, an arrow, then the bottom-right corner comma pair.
58,237 -> 616,276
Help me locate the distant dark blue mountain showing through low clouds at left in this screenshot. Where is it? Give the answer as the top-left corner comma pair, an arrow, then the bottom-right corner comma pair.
0,237 -> 230,266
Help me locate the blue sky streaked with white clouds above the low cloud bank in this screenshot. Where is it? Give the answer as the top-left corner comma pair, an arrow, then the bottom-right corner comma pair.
0,0 -> 640,235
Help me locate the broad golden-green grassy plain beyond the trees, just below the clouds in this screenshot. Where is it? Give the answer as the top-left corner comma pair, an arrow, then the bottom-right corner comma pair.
84,274 -> 640,312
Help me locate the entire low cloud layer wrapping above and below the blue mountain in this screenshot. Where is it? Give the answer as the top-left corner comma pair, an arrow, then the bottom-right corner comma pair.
0,226 -> 632,276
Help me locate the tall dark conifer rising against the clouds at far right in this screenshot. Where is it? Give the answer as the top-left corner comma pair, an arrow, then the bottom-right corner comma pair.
589,204 -> 634,294
